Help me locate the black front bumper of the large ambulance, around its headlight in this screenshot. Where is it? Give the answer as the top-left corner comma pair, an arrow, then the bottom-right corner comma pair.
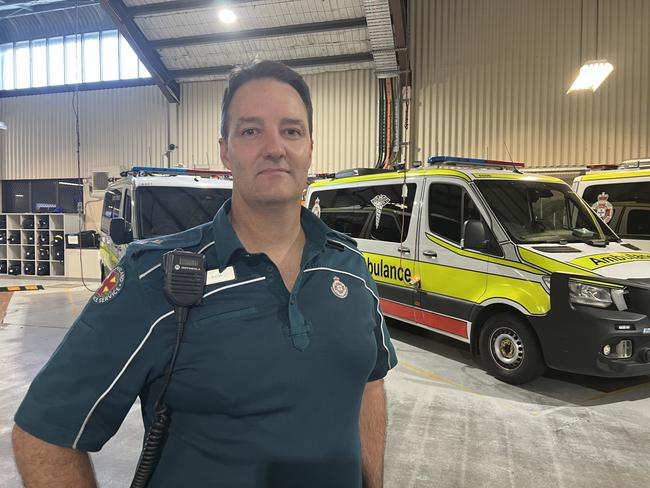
531,273 -> 650,377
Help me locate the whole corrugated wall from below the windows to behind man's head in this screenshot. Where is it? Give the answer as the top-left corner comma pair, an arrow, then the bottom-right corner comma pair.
0,70 -> 377,179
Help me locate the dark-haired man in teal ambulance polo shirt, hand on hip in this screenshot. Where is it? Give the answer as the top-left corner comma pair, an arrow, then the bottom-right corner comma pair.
13,62 -> 397,488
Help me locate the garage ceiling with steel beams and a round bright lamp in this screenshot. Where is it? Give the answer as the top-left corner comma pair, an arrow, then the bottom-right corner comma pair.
0,0 -> 409,102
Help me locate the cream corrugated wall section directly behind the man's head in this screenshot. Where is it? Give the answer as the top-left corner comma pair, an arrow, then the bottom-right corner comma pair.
177,70 -> 377,173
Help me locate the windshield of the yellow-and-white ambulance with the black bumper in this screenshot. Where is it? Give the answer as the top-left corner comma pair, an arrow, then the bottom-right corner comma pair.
476,180 -> 618,244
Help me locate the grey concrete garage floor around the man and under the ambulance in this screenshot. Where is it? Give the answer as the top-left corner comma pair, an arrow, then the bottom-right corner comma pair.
0,280 -> 650,488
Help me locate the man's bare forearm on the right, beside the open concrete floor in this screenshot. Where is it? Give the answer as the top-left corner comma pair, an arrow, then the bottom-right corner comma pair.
359,379 -> 386,488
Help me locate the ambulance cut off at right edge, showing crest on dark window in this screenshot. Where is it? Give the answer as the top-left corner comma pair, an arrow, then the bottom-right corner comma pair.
573,159 -> 650,252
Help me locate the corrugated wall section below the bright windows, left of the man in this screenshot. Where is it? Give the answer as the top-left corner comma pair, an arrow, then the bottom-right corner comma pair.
0,86 -> 167,179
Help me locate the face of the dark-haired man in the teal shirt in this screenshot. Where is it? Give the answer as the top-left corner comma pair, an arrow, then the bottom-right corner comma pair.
219,78 -> 312,206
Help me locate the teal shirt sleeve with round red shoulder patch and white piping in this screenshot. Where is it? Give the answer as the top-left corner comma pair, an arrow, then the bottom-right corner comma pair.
15,258 -> 173,451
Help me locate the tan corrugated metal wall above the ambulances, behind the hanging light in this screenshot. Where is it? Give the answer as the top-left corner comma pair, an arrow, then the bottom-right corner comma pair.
410,0 -> 650,167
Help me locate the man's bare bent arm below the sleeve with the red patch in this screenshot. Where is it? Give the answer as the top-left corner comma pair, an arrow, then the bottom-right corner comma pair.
11,425 -> 97,488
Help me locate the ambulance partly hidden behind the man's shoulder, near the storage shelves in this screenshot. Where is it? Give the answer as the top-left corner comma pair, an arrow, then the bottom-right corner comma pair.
99,166 -> 232,281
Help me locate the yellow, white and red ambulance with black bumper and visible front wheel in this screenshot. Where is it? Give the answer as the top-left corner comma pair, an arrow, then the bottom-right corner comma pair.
307,156 -> 650,384
